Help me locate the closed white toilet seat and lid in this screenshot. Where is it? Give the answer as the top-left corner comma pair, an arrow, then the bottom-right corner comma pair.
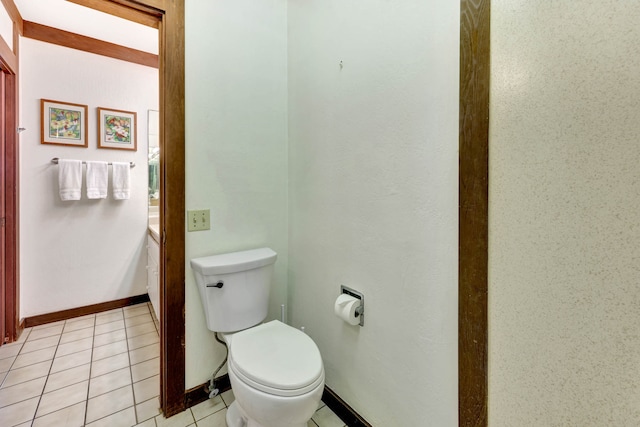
229,320 -> 324,397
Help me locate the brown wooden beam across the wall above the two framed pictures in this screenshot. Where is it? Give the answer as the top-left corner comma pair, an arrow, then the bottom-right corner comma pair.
23,21 -> 159,68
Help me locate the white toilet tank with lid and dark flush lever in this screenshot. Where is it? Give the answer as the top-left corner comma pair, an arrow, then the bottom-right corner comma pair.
191,248 -> 277,332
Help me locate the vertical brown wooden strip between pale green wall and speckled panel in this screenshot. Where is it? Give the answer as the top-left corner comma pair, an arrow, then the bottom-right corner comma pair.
458,0 -> 491,427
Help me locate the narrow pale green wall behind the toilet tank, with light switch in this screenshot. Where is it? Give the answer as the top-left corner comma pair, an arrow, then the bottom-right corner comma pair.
185,0 -> 287,389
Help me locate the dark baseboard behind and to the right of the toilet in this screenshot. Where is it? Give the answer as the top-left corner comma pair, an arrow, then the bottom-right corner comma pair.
184,374 -> 372,427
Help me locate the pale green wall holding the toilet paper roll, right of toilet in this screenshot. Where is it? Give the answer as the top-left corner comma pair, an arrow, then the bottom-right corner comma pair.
288,0 -> 460,426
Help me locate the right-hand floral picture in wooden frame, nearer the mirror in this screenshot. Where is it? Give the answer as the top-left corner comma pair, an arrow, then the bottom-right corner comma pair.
98,107 -> 138,151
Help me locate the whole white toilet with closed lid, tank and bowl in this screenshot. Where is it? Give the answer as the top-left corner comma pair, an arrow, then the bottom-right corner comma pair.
191,248 -> 324,427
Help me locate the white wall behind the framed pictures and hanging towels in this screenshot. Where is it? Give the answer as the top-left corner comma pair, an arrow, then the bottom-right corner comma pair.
20,38 -> 158,317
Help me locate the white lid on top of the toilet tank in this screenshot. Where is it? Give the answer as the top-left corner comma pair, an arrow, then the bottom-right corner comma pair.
191,248 -> 278,276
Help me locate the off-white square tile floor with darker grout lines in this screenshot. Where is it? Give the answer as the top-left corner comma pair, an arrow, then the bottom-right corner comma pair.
0,303 -> 345,427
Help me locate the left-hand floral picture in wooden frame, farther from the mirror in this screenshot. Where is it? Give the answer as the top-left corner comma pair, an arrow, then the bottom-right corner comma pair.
40,99 -> 88,148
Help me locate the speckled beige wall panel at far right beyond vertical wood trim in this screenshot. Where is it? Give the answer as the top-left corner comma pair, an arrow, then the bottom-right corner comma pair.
489,0 -> 640,427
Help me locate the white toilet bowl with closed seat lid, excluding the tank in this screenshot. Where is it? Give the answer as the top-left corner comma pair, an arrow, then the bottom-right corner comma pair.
224,320 -> 324,427
